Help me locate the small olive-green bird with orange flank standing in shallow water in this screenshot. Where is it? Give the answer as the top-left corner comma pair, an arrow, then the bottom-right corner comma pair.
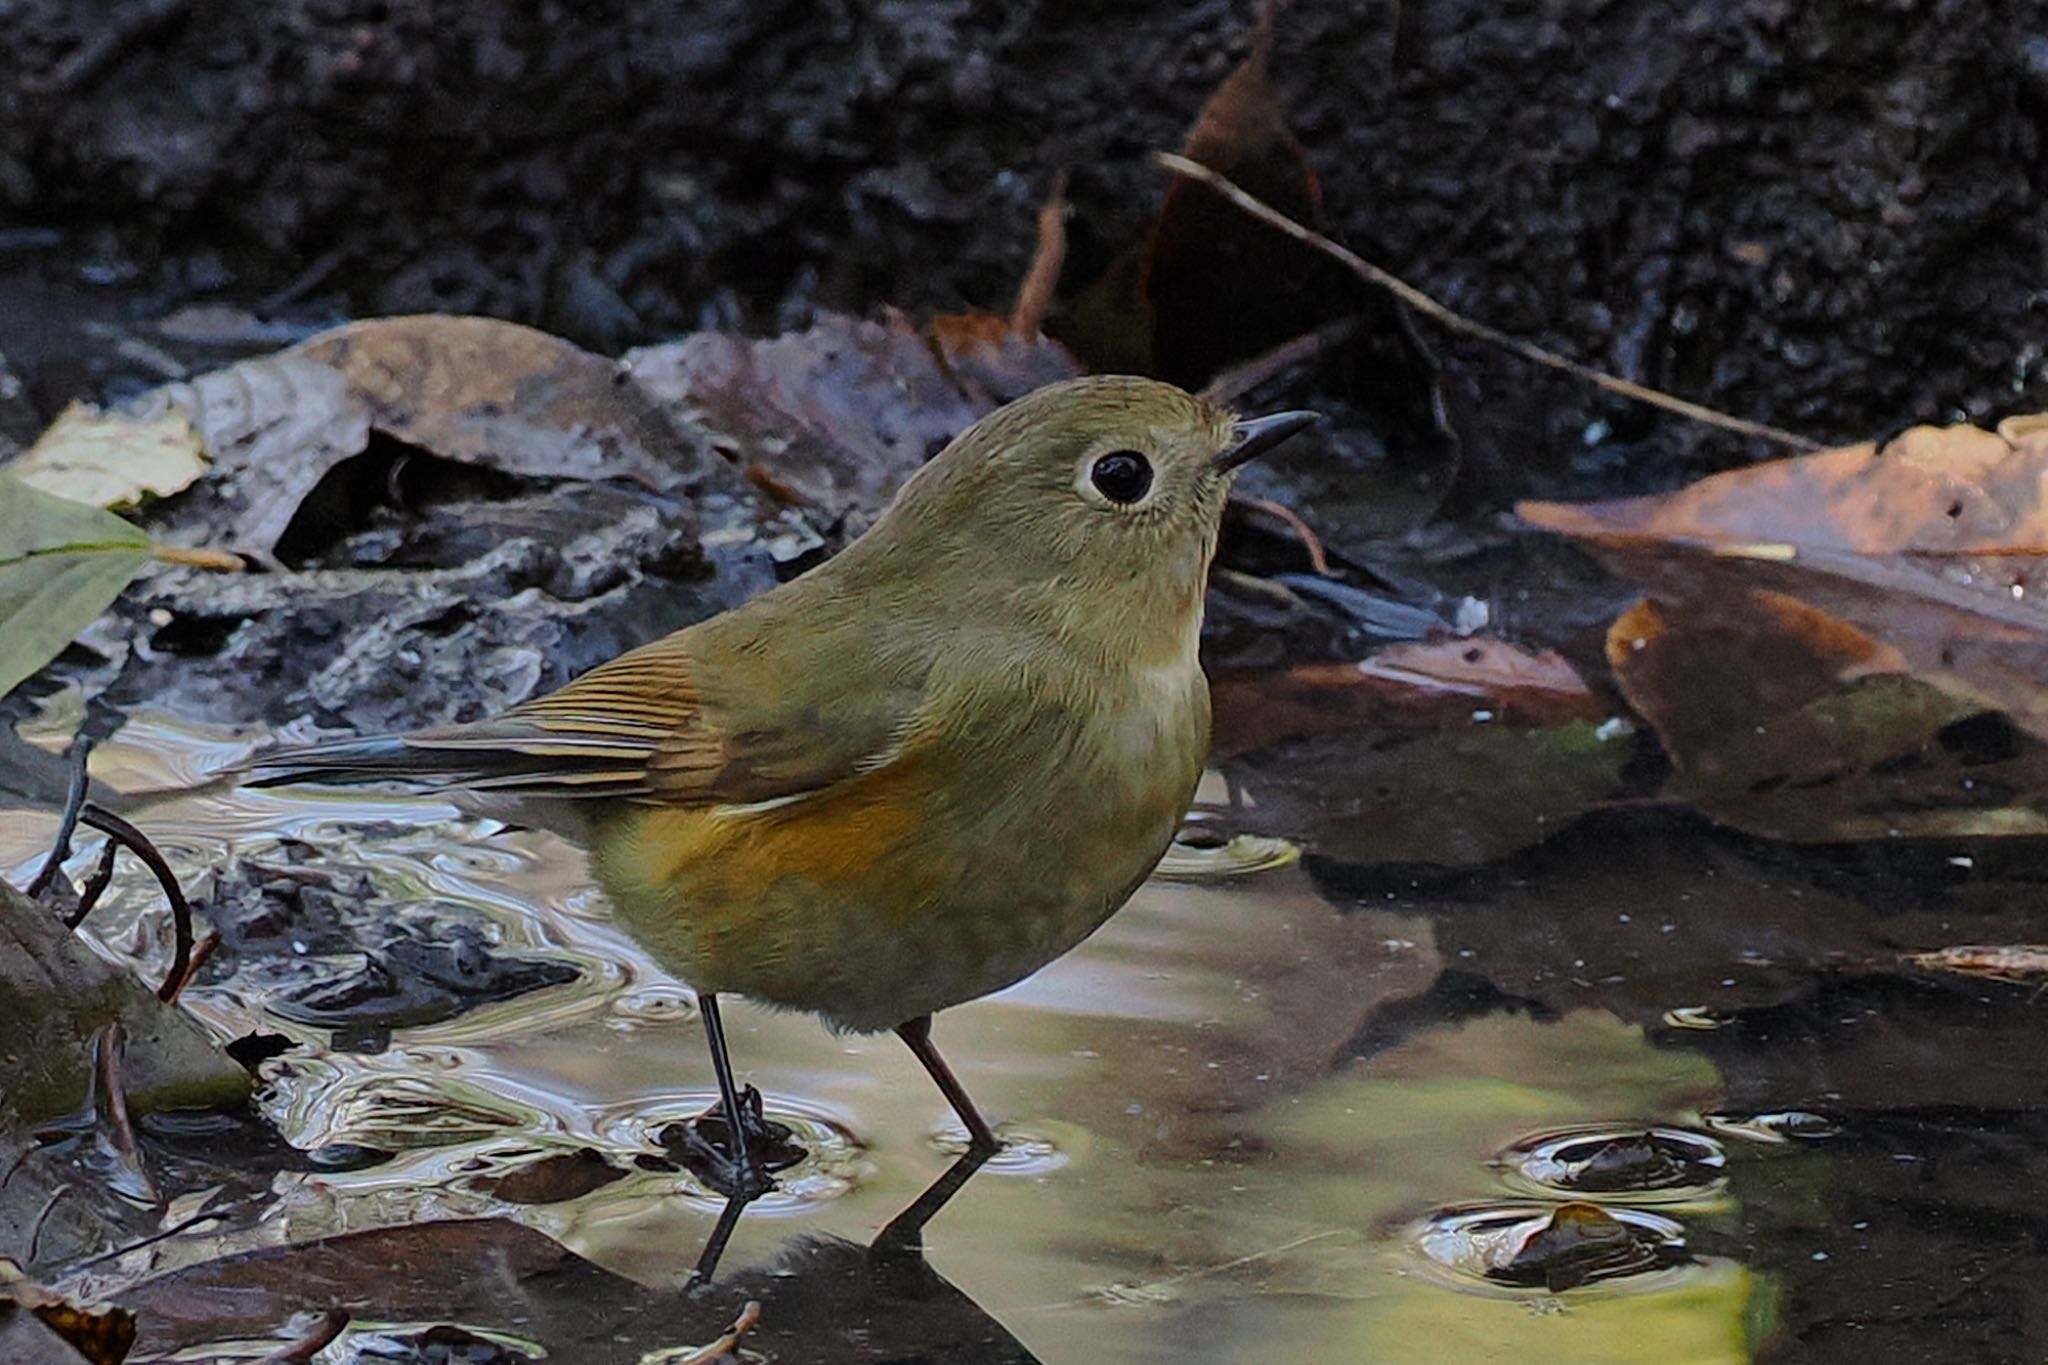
256,377 -> 1315,1181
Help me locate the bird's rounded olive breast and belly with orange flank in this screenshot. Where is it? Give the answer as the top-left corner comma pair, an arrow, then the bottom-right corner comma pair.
596,646 -> 1208,1029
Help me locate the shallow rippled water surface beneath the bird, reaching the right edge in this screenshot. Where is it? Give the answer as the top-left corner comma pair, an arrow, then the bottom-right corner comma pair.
0,720 -> 2048,1365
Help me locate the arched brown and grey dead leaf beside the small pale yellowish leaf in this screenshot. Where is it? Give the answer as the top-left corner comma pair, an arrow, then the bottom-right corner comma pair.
127,315 -> 707,551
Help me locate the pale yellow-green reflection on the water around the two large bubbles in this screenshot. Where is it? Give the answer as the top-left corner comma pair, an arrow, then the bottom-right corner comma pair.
1048,1011 -> 1753,1363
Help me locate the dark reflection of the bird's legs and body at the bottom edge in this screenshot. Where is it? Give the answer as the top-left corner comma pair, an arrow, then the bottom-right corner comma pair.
688,1150 -> 1038,1365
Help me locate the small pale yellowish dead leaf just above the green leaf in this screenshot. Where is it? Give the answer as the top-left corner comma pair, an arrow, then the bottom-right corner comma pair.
6,403 -> 207,508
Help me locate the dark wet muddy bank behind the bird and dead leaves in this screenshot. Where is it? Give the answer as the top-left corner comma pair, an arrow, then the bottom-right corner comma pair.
0,0 -> 2048,501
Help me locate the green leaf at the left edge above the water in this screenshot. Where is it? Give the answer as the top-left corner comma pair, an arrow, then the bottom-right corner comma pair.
0,473 -> 150,696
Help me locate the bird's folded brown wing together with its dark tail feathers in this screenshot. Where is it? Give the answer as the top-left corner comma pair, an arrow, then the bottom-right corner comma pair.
252,632 -> 915,806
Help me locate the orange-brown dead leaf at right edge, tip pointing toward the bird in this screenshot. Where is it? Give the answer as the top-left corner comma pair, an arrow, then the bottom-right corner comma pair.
1520,420 -> 2048,737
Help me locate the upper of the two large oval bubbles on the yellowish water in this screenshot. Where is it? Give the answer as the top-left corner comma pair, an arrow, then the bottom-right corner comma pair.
1493,1126 -> 1729,1203
